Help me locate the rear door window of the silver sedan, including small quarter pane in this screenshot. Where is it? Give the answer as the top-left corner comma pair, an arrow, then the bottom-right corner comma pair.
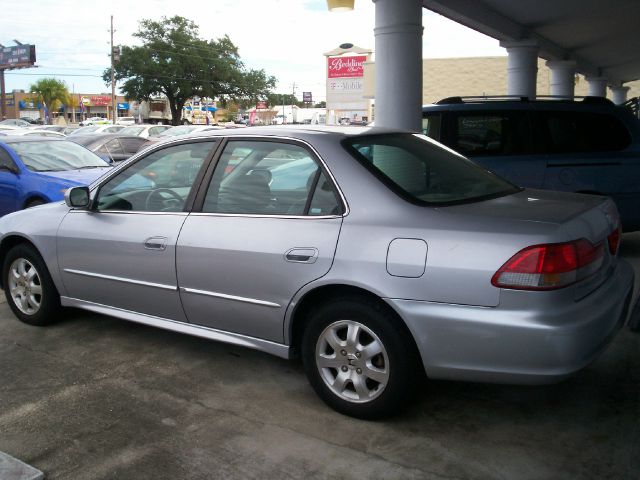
203,141 -> 342,216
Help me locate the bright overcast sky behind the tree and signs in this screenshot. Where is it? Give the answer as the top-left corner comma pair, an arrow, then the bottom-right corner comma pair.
0,0 -> 506,101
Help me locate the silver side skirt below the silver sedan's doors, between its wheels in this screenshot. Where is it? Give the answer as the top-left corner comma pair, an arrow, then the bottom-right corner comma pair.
60,296 -> 291,359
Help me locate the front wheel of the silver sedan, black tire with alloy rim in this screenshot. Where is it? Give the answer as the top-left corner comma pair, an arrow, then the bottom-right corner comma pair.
2,244 -> 62,326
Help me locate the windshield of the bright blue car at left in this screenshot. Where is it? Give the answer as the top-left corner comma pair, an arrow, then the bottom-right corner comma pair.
10,140 -> 108,172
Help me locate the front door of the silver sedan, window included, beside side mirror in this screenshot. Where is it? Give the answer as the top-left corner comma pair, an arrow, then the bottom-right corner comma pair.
58,139 -> 215,321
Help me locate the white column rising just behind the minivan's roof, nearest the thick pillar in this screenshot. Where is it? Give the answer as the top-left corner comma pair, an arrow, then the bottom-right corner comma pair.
500,39 -> 539,99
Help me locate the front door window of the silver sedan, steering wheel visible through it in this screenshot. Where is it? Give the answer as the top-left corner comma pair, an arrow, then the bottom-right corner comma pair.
95,141 -> 215,212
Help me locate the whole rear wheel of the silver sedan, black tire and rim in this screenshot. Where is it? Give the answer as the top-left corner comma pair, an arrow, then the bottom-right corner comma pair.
301,299 -> 424,419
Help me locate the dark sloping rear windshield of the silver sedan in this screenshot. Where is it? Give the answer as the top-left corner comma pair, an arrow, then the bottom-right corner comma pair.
344,133 -> 520,205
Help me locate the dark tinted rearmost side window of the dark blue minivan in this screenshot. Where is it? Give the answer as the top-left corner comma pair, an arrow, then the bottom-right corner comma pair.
534,111 -> 631,154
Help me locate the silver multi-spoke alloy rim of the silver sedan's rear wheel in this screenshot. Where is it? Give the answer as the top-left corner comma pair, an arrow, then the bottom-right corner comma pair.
316,320 -> 389,403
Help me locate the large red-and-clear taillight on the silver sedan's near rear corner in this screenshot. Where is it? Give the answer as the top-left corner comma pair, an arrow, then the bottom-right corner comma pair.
491,239 -> 604,290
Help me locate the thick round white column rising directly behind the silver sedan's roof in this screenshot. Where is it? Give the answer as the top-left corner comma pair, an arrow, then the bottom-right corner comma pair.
373,0 -> 422,131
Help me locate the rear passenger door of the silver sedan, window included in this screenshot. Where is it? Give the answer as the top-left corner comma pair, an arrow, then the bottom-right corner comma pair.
177,139 -> 345,342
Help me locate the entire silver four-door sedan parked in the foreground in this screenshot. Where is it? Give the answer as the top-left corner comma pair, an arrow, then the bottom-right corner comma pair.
0,127 -> 633,418
